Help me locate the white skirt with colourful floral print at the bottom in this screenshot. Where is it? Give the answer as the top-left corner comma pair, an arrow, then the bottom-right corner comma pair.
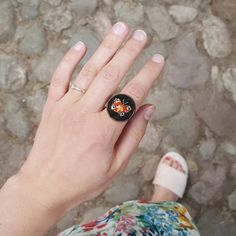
58,200 -> 200,236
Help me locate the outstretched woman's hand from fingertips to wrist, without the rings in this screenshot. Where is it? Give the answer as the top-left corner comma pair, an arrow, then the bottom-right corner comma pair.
10,23 -> 164,218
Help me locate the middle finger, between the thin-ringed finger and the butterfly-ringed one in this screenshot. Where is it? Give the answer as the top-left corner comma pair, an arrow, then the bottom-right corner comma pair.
80,30 -> 147,112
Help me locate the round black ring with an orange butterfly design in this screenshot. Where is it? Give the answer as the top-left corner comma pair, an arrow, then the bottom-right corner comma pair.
107,93 -> 136,121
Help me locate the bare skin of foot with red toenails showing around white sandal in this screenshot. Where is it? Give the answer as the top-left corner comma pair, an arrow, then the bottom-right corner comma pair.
151,156 -> 185,202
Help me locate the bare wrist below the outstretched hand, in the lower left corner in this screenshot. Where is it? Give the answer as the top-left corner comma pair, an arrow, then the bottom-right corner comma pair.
0,174 -> 68,235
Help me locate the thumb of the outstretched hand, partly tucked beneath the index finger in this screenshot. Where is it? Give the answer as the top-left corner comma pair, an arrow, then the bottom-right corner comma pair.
112,104 -> 155,170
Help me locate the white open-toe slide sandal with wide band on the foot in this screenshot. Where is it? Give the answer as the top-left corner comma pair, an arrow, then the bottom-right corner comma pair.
153,152 -> 188,198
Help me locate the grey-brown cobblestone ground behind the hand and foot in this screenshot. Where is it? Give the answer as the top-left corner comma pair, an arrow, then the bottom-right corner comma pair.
0,0 -> 236,236
